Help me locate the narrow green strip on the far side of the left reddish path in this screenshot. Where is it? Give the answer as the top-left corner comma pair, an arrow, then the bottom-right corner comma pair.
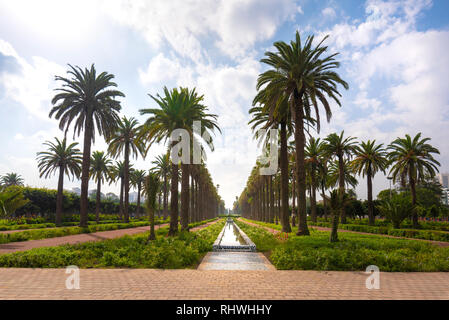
0,220 -> 169,244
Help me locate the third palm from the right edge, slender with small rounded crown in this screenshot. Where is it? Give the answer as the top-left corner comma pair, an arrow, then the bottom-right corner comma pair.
323,131 -> 356,224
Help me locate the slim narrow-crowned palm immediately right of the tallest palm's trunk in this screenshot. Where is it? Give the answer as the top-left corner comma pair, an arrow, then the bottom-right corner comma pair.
305,137 -> 324,222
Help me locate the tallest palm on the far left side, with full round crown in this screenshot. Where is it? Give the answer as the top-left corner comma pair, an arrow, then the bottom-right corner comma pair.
49,64 -> 125,227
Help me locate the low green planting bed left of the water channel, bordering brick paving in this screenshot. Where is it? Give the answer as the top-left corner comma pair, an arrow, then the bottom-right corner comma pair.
0,220 -> 224,269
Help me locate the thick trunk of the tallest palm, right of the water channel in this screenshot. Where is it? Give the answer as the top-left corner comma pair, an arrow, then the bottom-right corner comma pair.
291,94 -> 310,236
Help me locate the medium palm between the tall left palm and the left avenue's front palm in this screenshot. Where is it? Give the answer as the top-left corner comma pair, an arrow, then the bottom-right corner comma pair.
108,117 -> 144,223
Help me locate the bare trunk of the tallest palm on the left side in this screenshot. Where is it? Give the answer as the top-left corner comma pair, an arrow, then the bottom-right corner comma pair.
80,112 -> 93,228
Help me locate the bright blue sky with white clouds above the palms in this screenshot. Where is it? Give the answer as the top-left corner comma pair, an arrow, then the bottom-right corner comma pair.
0,0 -> 449,207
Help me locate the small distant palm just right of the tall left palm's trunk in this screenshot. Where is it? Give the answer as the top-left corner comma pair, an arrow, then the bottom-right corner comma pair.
90,151 -> 112,223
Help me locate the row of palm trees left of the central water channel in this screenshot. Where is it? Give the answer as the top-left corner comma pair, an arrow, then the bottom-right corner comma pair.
32,65 -> 221,235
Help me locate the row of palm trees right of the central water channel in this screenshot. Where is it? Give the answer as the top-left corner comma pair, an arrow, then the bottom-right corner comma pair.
239,32 -> 439,239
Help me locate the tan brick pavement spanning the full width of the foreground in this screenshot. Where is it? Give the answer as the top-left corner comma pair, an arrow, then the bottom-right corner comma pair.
0,269 -> 449,300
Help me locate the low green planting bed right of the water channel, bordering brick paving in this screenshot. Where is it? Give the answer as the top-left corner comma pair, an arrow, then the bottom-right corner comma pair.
233,221 -> 449,272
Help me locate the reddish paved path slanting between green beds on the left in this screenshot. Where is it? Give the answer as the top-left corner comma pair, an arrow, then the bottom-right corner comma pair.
0,220 -> 218,254
